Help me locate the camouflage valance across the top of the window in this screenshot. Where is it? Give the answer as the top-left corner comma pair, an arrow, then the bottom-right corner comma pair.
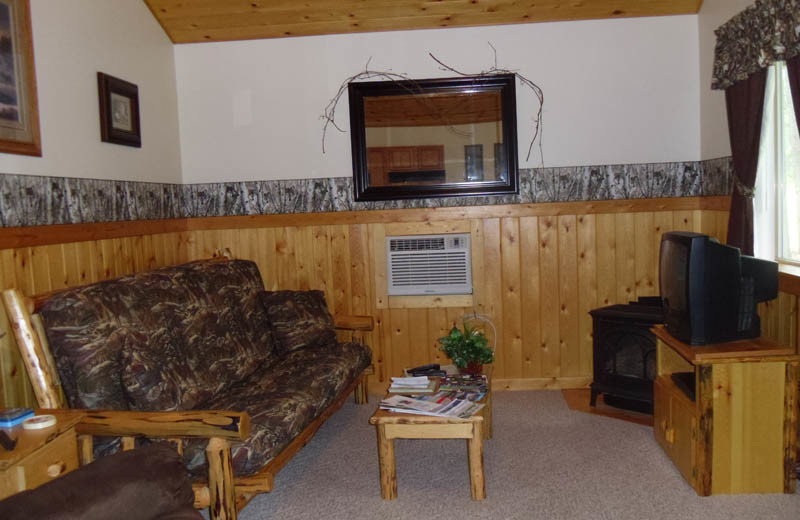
711,0 -> 800,89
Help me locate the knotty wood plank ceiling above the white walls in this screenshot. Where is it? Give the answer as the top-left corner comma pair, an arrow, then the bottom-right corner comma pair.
144,0 -> 703,43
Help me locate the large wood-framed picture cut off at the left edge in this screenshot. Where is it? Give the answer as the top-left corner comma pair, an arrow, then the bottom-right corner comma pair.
0,0 -> 42,156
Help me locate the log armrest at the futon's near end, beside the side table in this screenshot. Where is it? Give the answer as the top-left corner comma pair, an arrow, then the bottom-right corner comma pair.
75,410 -> 250,440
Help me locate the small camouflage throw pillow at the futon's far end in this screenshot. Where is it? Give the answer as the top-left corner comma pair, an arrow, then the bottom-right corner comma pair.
259,291 -> 336,354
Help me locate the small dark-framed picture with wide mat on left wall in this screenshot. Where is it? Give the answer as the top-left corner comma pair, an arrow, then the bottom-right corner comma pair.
97,72 -> 142,148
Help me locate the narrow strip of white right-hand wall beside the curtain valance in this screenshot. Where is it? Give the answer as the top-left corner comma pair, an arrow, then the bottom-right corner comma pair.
697,0 -> 755,159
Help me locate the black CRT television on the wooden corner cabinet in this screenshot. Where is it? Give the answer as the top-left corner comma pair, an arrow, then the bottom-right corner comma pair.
659,231 -> 778,345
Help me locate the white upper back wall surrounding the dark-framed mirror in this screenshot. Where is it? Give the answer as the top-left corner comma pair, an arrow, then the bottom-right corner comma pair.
175,16 -> 700,183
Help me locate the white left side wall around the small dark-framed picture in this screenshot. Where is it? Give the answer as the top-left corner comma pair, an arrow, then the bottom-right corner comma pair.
0,0 -> 181,182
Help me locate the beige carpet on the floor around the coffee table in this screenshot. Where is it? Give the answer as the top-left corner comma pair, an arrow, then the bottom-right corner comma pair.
239,391 -> 800,520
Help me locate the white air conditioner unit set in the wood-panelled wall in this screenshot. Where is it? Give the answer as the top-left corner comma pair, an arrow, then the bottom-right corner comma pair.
386,233 -> 472,296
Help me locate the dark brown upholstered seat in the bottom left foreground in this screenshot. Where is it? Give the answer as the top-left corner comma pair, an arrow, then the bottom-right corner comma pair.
0,443 -> 203,520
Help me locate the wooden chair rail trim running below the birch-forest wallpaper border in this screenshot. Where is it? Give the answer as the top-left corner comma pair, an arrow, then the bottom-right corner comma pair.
0,196 -> 730,249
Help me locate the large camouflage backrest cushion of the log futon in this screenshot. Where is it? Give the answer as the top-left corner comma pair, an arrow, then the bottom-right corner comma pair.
40,260 -> 274,410
